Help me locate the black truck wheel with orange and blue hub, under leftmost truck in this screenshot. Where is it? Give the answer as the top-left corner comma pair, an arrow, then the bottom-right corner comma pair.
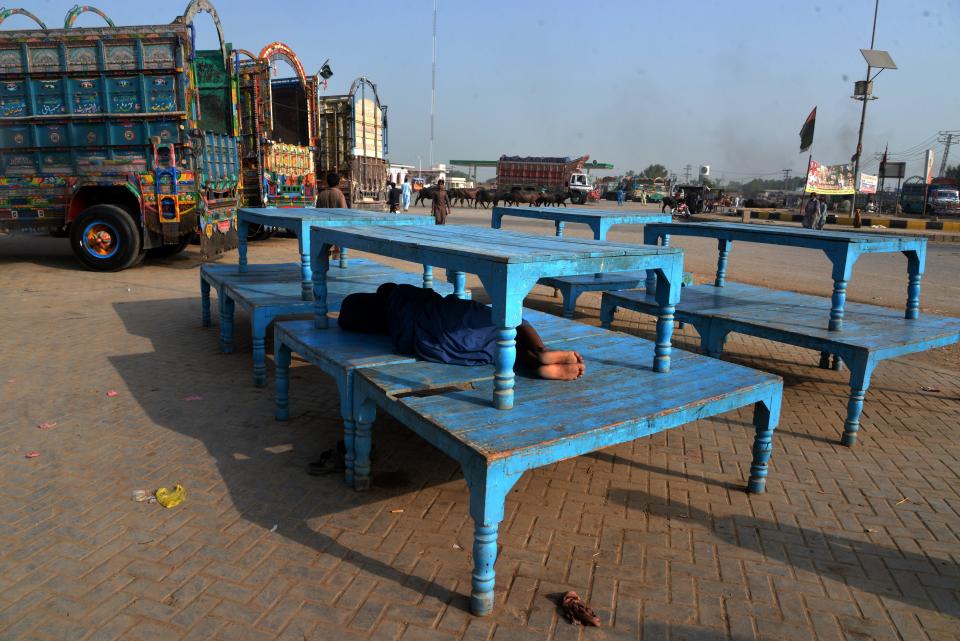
70,205 -> 144,272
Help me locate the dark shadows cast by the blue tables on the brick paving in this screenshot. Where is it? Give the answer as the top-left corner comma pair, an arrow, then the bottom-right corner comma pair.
110,298 -> 960,624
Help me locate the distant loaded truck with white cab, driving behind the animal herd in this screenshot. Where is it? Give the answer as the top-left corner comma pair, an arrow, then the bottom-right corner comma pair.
497,156 -> 594,204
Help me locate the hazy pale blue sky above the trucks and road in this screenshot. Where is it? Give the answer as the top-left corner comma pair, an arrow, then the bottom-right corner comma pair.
16,0 -> 960,179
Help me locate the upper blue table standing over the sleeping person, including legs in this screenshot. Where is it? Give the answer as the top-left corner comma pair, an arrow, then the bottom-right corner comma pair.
310,225 -> 683,409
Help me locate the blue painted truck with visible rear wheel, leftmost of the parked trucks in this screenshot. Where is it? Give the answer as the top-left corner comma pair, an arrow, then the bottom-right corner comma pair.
0,0 -> 239,271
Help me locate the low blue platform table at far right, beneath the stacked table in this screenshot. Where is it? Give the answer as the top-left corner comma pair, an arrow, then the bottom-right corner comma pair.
600,283 -> 960,445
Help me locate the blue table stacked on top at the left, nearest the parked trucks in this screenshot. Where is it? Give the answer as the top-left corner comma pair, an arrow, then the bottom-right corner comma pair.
237,207 -> 435,300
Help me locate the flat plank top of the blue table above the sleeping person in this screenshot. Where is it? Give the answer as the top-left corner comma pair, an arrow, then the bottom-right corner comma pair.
314,225 -> 682,264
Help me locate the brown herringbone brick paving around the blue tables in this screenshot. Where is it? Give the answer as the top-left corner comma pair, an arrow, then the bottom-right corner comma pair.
0,240 -> 960,641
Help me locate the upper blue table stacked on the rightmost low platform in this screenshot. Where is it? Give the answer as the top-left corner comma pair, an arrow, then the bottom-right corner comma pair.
643,222 -> 927,331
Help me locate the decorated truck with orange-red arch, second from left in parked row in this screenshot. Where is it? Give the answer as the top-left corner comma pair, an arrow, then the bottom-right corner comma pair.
239,42 -> 317,212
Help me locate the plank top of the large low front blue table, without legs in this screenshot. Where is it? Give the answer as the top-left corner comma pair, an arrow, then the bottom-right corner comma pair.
360,332 -> 781,461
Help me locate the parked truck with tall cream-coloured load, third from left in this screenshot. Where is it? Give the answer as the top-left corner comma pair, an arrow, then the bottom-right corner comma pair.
316,77 -> 390,211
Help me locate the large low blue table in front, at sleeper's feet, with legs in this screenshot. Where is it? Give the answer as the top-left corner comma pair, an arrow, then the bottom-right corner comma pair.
351,332 -> 783,615
